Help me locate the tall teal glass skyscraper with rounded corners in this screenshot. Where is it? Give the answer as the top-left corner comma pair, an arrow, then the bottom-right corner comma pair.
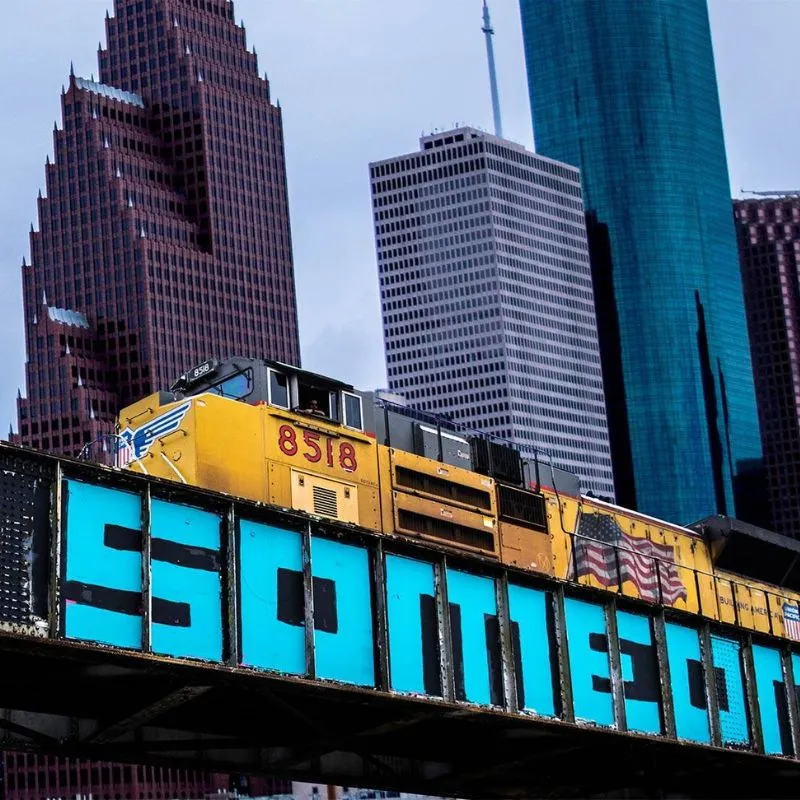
521,0 -> 761,523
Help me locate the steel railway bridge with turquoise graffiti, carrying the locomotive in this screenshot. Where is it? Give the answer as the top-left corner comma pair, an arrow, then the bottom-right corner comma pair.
0,445 -> 800,798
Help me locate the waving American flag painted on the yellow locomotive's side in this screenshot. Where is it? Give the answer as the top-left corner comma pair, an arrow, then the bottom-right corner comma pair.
570,514 -> 688,604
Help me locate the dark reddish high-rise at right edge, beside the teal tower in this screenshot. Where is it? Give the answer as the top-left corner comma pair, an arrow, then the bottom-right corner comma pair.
733,195 -> 800,537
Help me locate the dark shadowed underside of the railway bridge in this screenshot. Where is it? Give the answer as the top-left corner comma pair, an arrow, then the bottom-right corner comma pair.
0,634 -> 800,798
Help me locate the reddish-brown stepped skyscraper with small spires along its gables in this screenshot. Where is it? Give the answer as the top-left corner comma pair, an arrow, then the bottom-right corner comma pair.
15,0 -> 300,454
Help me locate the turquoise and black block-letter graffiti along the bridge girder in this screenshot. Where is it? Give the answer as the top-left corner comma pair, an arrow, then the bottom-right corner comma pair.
61,480 -> 800,755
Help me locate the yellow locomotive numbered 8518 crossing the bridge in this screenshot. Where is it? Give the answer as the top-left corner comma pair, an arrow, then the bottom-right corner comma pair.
119,358 -> 800,639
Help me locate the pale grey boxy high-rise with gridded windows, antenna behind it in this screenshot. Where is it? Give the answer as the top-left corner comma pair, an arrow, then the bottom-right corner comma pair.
370,128 -> 614,497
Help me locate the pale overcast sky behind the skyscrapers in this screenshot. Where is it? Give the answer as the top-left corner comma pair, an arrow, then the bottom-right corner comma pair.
0,0 -> 800,435
